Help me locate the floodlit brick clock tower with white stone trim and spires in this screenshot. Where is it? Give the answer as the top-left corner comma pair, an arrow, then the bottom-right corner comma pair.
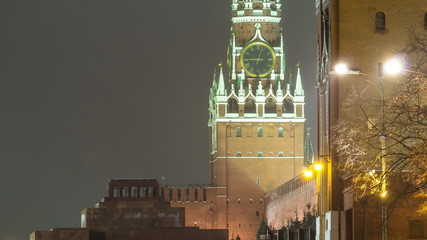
208,0 -> 305,240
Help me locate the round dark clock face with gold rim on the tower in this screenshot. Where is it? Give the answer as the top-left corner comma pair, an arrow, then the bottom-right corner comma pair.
240,42 -> 276,77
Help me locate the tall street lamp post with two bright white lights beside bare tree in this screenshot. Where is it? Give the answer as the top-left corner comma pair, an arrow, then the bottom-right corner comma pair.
331,63 -> 390,240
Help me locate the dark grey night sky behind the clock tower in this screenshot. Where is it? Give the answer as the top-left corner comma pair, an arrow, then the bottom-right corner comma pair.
0,0 -> 316,240
